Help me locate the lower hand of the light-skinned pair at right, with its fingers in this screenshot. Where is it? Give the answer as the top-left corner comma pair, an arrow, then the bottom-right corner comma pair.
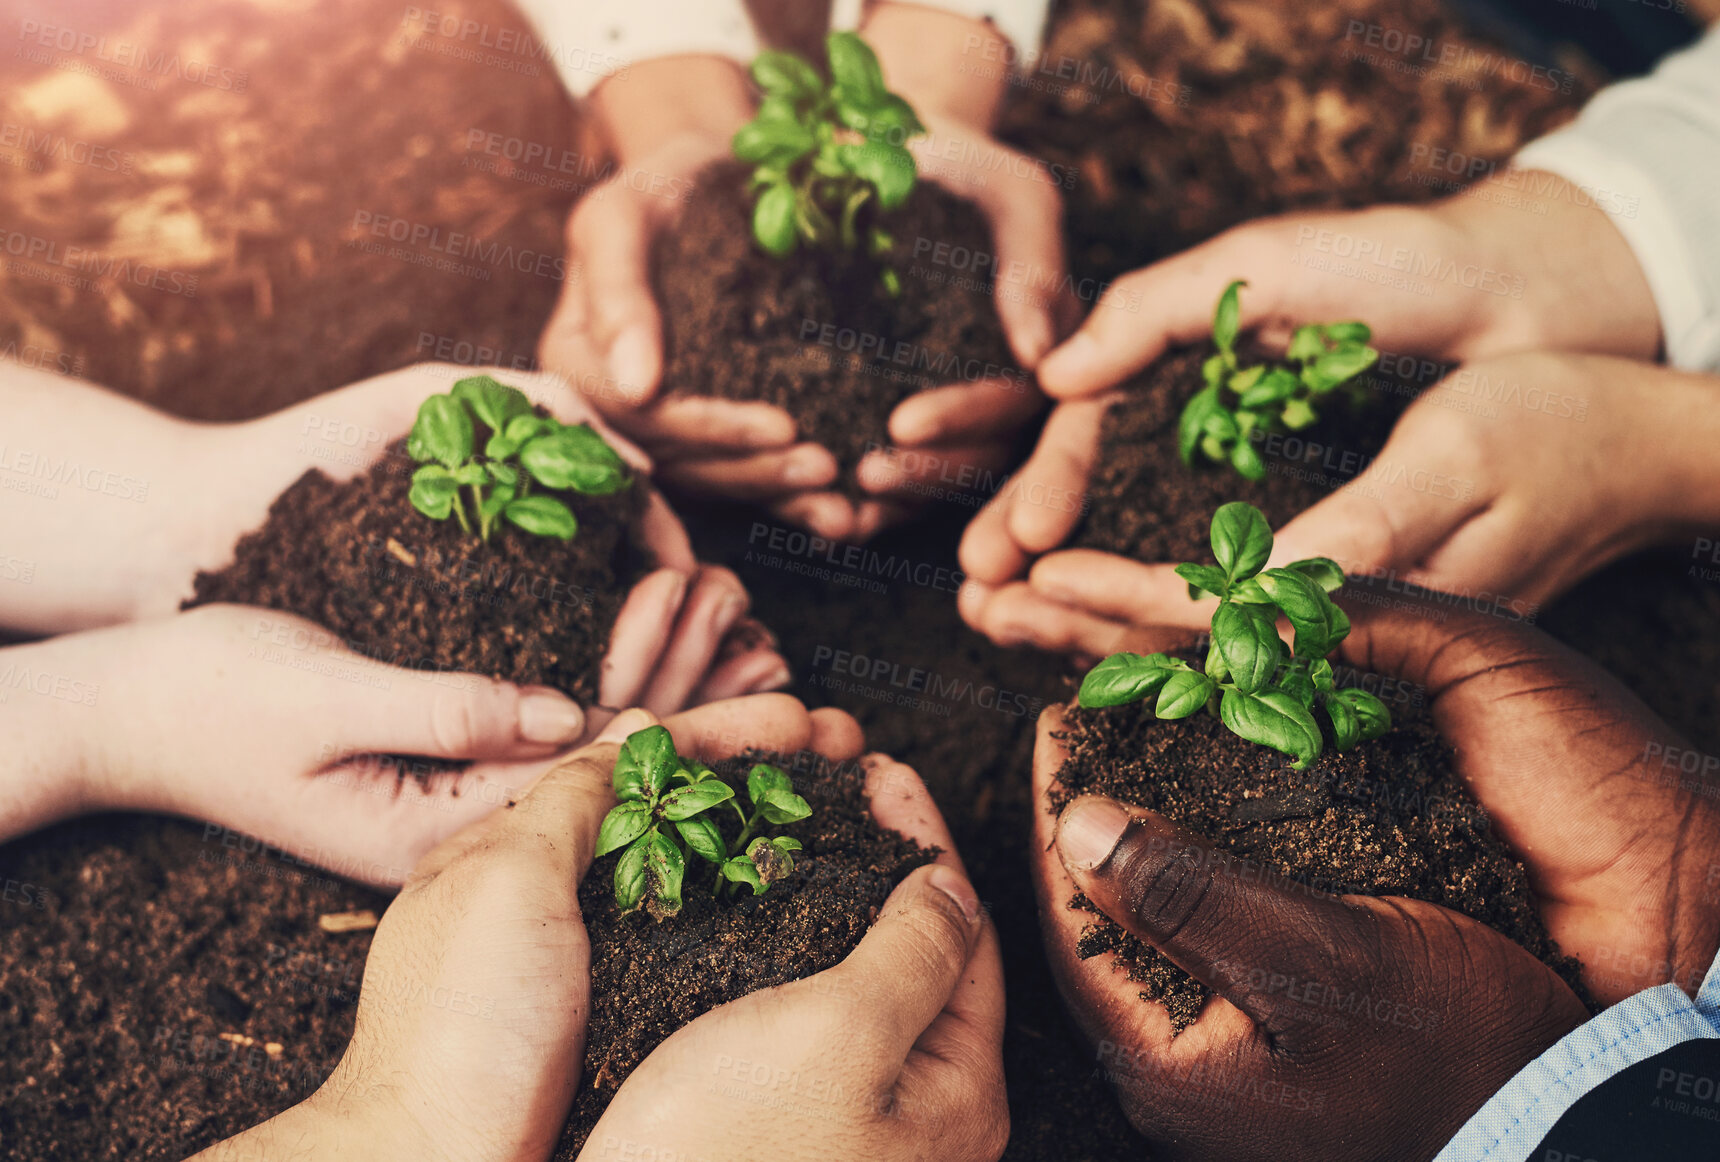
961,352 -> 1720,655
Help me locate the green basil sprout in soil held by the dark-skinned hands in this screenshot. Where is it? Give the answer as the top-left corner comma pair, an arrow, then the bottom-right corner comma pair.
1077,502 -> 1391,770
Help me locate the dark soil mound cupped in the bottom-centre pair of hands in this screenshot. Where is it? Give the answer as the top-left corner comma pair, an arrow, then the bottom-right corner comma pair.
554,753 -> 937,1162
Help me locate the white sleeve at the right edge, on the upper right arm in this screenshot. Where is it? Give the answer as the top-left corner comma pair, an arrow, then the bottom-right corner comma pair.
1512,26 -> 1720,371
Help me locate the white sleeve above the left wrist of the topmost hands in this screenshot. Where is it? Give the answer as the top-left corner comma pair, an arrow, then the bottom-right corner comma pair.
502,0 -> 759,96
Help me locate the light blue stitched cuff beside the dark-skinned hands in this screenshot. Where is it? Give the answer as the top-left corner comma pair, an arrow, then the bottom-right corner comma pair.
1434,957 -> 1720,1162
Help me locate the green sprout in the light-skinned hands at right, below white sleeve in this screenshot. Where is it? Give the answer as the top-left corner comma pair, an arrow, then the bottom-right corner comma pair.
1176,280 -> 1379,480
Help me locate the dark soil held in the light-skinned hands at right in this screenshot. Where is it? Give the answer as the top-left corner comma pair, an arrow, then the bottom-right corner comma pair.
1072,340 -> 1416,564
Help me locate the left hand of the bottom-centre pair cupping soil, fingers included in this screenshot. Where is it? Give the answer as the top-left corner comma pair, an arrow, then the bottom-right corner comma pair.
190,694 -> 862,1162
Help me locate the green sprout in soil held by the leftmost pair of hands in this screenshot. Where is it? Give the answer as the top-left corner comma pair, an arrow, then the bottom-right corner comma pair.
406,375 -> 630,541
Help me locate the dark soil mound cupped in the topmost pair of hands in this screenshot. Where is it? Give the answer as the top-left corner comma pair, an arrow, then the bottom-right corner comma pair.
655,162 -> 1034,480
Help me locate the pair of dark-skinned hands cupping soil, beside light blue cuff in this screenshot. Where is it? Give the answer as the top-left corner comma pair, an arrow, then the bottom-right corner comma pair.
1034,594 -> 1720,1160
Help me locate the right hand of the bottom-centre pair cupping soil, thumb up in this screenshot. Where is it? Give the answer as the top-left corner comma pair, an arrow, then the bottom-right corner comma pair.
580,755 -> 1010,1162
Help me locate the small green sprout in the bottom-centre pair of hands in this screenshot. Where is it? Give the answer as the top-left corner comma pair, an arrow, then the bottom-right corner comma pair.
597,725 -> 812,920
